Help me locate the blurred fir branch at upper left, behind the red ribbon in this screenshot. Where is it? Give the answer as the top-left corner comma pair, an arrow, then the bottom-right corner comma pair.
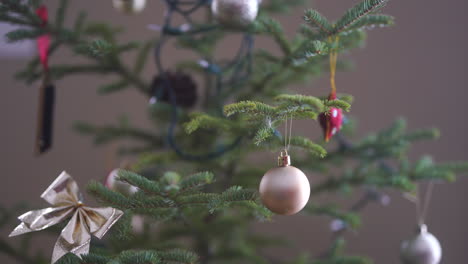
0,1 -> 148,92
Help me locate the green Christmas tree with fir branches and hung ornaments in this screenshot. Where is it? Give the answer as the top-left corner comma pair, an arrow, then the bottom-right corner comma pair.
0,0 -> 468,264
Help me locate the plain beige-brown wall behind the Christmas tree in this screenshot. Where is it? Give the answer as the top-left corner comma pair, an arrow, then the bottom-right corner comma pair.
0,0 -> 468,264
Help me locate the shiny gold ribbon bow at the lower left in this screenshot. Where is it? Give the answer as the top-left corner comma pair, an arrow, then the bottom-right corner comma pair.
10,171 -> 123,263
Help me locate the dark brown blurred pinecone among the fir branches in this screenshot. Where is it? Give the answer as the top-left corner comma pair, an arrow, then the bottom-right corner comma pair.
150,71 -> 197,108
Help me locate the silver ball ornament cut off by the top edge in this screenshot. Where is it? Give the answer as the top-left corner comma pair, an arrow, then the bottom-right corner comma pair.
211,0 -> 261,28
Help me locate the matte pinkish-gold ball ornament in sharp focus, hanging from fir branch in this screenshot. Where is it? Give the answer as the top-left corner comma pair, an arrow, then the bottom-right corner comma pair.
260,153 -> 310,215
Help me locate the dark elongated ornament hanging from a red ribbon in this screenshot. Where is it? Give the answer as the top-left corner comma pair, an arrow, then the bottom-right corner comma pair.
35,6 -> 55,155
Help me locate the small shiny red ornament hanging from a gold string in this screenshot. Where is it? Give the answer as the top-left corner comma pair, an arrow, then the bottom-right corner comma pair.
319,37 -> 343,142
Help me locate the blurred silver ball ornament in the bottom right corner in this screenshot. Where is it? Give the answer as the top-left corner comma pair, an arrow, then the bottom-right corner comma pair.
401,225 -> 442,264
